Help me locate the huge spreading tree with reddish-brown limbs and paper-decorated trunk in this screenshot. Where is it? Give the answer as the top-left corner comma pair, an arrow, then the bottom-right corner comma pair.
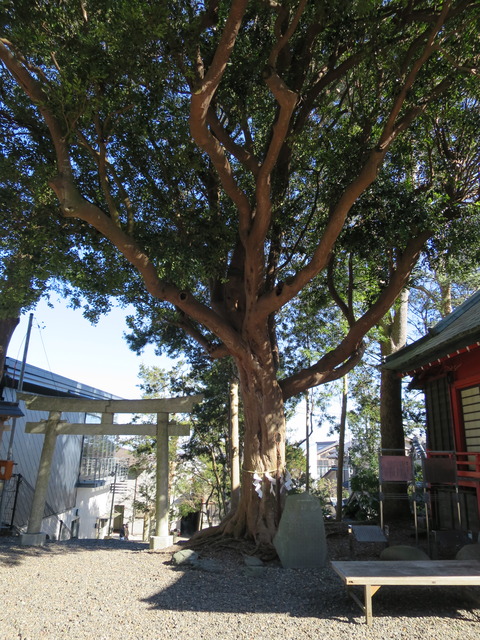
0,0 -> 479,544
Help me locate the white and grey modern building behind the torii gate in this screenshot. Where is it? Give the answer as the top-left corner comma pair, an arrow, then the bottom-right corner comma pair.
0,358 -> 135,539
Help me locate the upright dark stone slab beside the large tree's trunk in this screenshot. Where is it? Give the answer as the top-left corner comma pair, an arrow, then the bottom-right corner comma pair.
273,493 -> 327,569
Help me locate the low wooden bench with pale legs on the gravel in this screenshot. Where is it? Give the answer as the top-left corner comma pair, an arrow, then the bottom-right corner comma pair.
332,560 -> 480,625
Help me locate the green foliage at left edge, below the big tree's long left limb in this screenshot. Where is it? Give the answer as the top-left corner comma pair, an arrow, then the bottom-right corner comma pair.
0,70 -> 132,378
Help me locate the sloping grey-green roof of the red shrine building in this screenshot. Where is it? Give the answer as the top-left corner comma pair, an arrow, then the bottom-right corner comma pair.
383,291 -> 480,373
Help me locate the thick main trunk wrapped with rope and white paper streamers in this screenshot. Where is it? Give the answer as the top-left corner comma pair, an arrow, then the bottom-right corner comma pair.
224,340 -> 286,547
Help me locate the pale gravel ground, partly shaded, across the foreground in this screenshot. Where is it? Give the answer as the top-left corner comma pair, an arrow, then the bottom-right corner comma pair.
0,539 -> 480,640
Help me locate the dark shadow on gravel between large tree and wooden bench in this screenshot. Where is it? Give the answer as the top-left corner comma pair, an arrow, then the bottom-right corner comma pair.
139,567 -> 480,624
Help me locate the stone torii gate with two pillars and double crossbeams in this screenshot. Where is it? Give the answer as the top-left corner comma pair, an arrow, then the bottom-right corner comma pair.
18,393 -> 203,549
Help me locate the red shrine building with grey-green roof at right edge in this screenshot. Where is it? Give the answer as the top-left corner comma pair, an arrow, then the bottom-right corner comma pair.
384,291 -> 480,531
